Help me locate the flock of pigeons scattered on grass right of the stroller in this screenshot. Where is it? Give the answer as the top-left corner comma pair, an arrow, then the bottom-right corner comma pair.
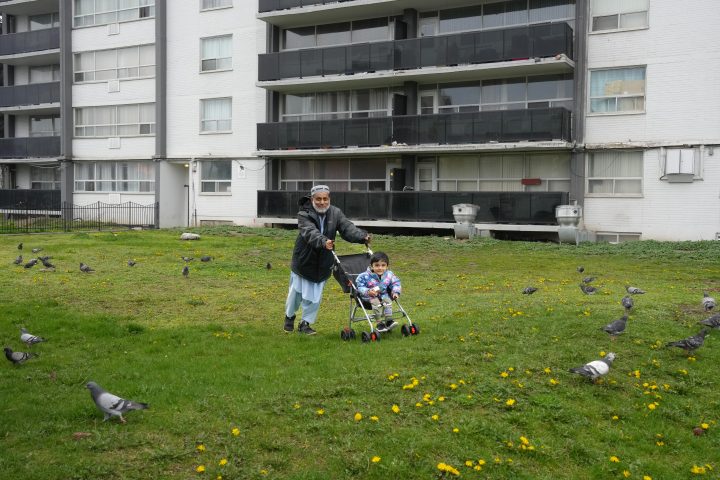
522,266 -> 720,382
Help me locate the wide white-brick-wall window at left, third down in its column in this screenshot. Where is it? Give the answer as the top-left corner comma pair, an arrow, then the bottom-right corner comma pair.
75,103 -> 155,138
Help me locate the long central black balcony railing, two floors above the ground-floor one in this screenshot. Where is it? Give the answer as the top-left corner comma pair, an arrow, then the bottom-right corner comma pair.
258,22 -> 573,81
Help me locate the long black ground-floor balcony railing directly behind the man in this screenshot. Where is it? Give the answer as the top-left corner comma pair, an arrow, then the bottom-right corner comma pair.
257,190 -> 569,225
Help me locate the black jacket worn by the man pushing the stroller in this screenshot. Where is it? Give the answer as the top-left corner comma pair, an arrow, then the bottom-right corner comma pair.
290,196 -> 368,282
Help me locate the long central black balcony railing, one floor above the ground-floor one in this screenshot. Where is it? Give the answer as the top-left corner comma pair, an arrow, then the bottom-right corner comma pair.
257,108 -> 571,150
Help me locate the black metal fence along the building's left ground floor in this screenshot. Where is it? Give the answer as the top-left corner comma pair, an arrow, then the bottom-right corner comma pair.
0,202 -> 158,233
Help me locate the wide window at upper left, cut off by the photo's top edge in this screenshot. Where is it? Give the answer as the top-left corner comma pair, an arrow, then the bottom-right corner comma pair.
73,0 -> 155,27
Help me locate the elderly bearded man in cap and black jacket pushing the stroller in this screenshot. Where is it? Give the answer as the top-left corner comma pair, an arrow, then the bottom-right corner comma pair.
283,185 -> 370,335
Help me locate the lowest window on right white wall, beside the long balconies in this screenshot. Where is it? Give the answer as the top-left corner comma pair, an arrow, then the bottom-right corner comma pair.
586,151 -> 643,197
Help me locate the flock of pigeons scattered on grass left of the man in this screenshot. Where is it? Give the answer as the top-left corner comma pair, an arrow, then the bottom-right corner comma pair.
4,243 -> 218,423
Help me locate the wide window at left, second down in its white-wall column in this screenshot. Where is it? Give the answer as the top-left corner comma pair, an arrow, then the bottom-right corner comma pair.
74,45 -> 155,83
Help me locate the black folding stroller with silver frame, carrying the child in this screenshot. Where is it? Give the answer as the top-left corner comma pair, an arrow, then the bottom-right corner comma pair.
332,248 -> 420,342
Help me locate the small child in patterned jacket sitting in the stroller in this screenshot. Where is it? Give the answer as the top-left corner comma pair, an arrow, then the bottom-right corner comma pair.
355,252 -> 402,332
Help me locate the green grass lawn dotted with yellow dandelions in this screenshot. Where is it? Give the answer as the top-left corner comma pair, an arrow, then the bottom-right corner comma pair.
0,228 -> 720,480
